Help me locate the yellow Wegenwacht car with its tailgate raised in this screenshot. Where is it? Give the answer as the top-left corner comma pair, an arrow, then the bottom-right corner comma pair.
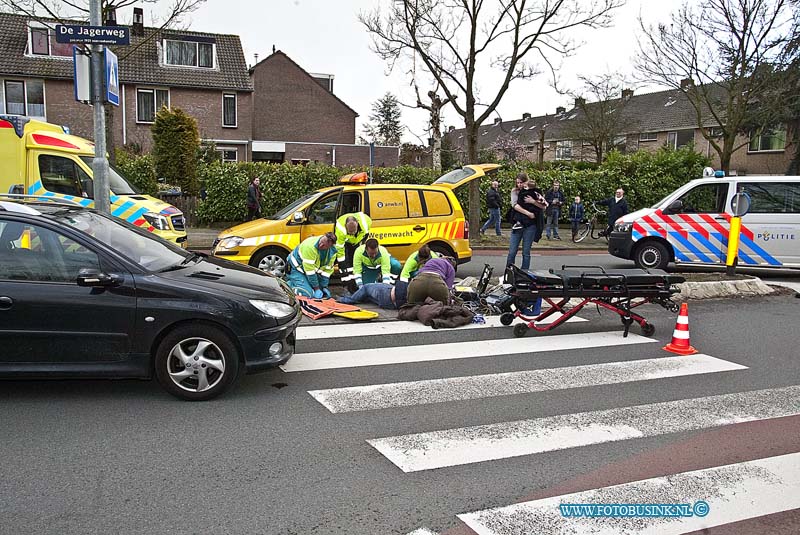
213,164 -> 500,276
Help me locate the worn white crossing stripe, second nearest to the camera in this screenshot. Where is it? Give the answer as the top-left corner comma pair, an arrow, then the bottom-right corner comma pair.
367,386 -> 800,472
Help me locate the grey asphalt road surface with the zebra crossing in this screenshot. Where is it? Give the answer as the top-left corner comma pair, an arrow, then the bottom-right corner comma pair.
0,255 -> 800,535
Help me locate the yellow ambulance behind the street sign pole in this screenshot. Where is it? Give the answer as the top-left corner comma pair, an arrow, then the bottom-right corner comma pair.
0,115 -> 187,247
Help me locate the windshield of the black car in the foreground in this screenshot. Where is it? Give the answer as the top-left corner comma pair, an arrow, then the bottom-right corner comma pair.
58,210 -> 195,271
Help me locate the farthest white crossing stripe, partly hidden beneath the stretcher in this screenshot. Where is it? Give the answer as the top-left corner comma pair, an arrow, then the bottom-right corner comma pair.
297,314 -> 588,340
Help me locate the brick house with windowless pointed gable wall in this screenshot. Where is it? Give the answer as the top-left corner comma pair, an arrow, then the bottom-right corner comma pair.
249,50 -> 399,167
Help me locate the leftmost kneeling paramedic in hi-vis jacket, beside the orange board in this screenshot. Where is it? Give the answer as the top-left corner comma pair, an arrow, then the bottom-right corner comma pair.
286,232 -> 336,299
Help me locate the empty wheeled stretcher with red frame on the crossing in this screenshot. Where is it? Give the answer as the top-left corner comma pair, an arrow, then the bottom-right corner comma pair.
500,266 -> 685,337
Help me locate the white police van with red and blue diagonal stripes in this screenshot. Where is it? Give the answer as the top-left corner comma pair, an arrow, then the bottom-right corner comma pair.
608,175 -> 800,269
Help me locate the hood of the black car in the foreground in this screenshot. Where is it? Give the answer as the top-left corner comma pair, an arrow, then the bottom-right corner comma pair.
158,256 -> 296,306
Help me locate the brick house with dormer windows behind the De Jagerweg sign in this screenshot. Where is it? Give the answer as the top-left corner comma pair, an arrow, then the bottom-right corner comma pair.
0,12 -> 253,161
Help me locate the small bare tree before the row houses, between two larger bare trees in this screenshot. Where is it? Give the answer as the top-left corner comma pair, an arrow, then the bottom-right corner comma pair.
564,73 -> 633,163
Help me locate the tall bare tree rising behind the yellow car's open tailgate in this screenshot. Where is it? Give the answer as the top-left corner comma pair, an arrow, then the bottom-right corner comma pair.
359,0 -> 624,239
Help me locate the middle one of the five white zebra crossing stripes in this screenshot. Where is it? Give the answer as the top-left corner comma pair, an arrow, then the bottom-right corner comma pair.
309,354 -> 747,413
